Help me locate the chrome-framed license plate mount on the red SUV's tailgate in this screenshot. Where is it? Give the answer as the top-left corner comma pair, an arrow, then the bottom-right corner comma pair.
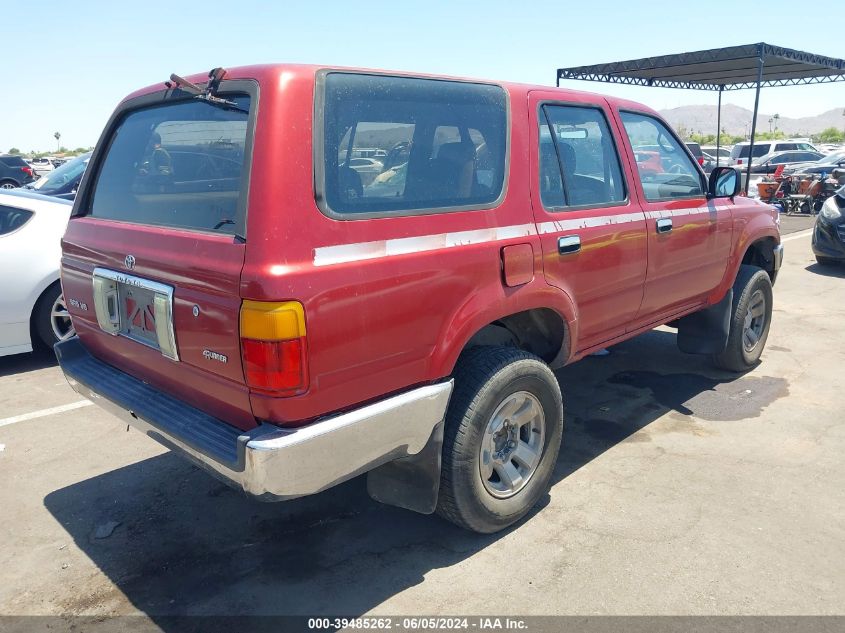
94,268 -> 179,360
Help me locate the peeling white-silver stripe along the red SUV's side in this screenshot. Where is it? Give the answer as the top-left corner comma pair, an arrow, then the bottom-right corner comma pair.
314,206 -> 729,266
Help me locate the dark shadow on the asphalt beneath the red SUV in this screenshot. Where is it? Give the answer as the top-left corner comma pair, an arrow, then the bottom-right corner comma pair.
44,331 -> 779,620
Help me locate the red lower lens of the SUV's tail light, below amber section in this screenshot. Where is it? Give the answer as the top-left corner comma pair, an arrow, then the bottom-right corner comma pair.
241,339 -> 308,395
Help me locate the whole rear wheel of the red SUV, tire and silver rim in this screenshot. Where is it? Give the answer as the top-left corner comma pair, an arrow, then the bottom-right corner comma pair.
437,347 -> 563,533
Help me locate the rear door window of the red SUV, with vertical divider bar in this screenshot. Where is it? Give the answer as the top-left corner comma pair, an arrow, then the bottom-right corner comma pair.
539,104 -> 625,208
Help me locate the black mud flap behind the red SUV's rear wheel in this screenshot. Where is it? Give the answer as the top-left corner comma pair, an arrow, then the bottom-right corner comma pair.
367,421 -> 443,514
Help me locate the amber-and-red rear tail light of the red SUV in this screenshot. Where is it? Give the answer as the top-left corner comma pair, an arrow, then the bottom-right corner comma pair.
240,301 -> 308,396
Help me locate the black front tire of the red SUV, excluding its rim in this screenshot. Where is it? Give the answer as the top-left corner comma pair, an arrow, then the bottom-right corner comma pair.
713,265 -> 772,372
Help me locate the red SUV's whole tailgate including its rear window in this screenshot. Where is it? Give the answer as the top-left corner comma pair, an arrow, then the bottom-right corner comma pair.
62,82 -> 256,429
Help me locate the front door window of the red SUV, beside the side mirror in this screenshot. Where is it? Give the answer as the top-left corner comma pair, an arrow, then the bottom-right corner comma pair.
621,112 -> 704,201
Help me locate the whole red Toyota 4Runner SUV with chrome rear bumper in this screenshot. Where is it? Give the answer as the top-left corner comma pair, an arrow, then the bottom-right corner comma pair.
56,65 -> 782,532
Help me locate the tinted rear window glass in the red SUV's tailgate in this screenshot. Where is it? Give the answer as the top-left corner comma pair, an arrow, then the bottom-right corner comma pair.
89,94 -> 250,235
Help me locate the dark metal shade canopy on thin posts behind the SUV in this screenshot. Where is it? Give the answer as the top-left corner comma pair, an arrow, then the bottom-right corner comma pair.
557,42 -> 845,188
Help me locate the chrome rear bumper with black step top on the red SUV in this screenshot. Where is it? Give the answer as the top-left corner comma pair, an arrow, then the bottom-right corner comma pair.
55,338 -> 453,501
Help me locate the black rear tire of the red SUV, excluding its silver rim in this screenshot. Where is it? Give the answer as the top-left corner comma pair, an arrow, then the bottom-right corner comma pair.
437,347 -> 563,534
